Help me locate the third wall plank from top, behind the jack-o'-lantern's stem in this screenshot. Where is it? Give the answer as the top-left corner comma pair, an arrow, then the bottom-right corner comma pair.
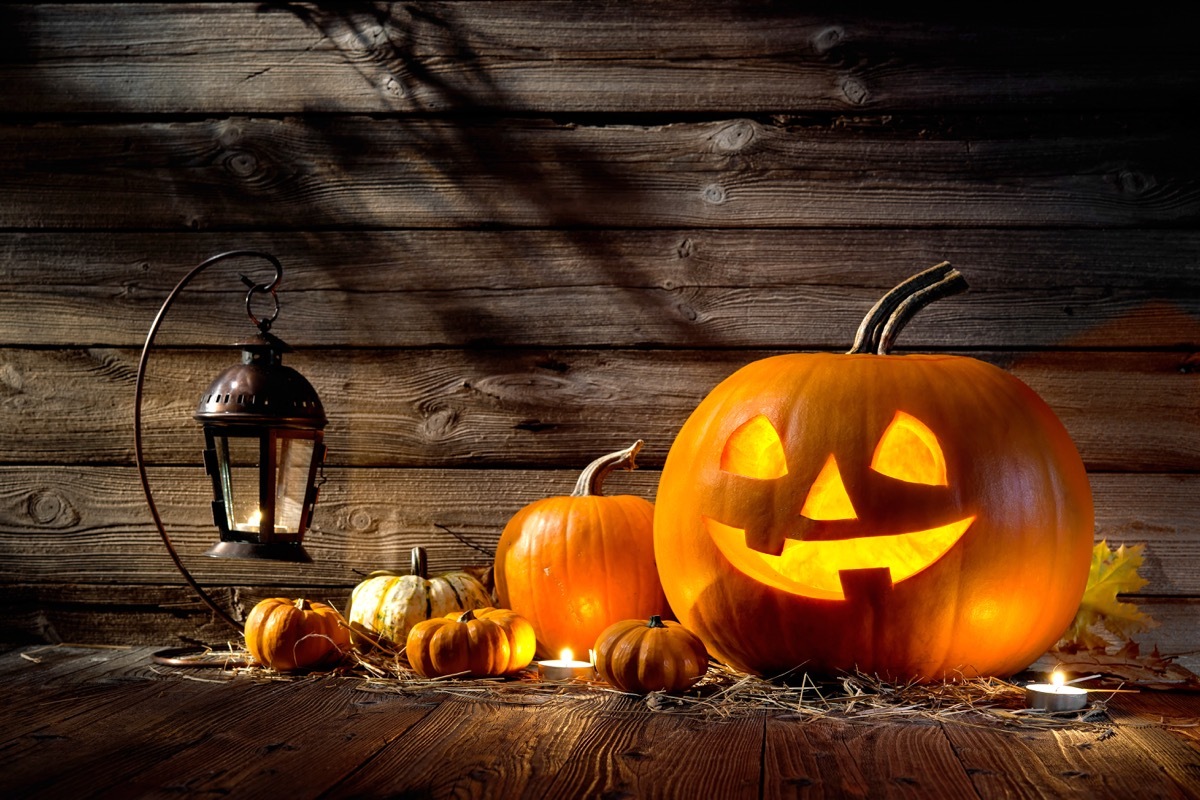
0,229 -> 1200,349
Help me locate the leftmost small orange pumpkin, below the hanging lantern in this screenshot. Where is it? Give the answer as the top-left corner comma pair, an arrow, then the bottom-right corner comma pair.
245,597 -> 350,672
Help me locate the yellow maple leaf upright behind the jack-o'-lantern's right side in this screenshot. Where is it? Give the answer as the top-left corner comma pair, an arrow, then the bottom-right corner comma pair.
1057,540 -> 1158,650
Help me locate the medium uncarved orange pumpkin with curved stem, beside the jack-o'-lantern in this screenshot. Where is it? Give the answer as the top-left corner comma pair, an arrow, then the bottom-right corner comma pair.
496,441 -> 668,657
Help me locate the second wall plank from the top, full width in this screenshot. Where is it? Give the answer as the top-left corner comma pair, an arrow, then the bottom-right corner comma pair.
0,116 -> 1200,230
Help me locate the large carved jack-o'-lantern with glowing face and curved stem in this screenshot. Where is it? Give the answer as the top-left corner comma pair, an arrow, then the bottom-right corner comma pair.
654,264 -> 1093,680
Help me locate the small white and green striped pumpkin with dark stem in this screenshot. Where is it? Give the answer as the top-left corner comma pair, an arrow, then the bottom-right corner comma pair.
347,547 -> 492,648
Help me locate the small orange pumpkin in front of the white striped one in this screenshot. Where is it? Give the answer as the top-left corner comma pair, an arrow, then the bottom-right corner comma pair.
406,610 -> 511,678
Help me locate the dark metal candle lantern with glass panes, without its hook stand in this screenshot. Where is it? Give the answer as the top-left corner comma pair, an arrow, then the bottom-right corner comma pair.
194,332 -> 326,561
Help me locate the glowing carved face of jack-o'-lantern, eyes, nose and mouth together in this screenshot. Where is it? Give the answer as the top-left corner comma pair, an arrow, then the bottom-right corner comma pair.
702,411 -> 976,600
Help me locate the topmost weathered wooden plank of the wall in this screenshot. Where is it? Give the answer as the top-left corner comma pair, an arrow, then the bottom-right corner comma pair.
0,2 -> 1200,113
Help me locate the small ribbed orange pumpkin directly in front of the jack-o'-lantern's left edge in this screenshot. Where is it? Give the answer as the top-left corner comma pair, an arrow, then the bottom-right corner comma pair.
594,616 -> 708,694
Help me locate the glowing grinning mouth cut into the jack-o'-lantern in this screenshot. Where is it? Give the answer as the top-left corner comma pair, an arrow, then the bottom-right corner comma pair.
704,516 -> 976,600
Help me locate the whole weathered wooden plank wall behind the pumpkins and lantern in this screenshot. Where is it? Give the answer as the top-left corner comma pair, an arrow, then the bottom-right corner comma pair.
0,6 -> 1200,666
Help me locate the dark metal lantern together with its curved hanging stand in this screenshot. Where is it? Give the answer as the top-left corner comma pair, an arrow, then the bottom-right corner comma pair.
133,249 -> 326,631
